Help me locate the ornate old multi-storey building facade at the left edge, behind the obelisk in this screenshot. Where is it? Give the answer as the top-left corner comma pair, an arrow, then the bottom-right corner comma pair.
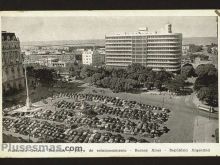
2,31 -> 25,93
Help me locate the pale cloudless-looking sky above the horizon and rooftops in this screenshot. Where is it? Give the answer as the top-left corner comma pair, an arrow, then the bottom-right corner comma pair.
2,16 -> 217,42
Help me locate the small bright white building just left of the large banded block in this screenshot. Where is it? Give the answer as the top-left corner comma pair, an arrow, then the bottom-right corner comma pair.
82,49 -> 104,66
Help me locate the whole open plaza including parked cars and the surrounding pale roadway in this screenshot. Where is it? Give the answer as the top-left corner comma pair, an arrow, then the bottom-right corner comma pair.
3,83 -> 218,143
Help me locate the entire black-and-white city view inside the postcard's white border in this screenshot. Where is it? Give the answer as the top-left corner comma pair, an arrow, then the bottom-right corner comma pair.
1,15 -> 219,143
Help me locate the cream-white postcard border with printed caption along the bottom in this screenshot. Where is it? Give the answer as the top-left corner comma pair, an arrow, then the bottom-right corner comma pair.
0,10 -> 220,157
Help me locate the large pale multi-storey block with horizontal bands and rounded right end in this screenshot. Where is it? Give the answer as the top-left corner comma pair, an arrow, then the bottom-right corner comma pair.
105,24 -> 182,72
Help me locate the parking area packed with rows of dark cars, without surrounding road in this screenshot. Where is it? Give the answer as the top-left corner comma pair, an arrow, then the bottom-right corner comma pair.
3,92 -> 170,143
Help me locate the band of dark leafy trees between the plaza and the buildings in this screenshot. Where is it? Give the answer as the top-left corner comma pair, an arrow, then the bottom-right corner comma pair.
27,64 -> 218,106
